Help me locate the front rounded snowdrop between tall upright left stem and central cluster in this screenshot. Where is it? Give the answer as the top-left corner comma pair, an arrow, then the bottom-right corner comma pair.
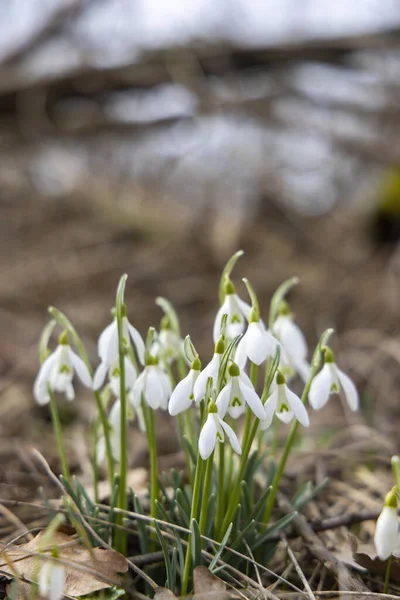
132,356 -> 172,410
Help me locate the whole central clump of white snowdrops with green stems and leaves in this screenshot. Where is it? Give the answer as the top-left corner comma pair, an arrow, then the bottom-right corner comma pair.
34,252 -> 358,595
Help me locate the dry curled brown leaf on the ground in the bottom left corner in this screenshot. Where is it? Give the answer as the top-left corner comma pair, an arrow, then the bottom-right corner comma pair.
0,531 -> 128,596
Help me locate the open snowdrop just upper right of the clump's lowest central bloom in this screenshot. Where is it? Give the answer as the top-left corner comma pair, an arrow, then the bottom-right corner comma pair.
216,363 -> 264,419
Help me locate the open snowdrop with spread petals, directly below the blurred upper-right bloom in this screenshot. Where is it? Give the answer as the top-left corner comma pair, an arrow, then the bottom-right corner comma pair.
260,372 -> 310,430
